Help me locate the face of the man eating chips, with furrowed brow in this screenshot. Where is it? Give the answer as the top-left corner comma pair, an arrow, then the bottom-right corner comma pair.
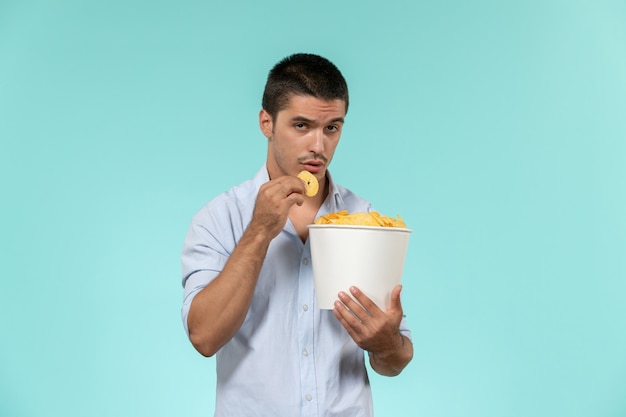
259,95 -> 346,184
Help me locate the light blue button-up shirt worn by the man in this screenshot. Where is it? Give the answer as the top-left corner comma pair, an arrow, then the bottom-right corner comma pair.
182,167 -> 410,417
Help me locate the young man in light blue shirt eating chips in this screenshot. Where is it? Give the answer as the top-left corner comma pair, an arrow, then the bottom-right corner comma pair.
182,54 -> 413,417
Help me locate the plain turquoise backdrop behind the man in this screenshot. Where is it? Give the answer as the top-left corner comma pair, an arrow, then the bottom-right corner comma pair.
0,0 -> 626,417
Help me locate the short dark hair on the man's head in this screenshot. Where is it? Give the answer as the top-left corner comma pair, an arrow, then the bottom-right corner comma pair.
262,53 -> 348,119
